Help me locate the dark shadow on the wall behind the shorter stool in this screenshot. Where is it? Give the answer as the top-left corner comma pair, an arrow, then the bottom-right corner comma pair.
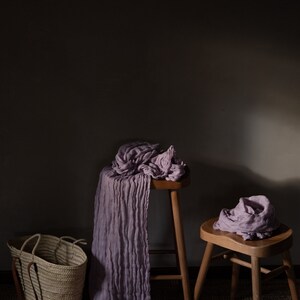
177,161 -> 300,265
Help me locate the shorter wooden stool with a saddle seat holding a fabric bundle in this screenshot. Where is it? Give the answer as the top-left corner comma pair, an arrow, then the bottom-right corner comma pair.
194,218 -> 298,300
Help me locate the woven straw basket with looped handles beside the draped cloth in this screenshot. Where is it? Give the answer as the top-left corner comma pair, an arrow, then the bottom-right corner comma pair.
7,234 -> 87,300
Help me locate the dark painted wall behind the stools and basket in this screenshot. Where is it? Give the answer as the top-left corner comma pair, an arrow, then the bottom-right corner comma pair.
0,0 -> 300,269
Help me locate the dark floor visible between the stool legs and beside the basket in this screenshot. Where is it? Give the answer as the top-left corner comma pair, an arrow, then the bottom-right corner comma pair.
0,278 -> 300,300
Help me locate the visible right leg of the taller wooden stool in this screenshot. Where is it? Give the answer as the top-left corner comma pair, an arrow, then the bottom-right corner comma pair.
170,190 -> 191,300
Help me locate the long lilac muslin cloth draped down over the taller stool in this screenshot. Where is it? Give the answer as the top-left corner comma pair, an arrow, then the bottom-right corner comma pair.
90,142 -> 185,300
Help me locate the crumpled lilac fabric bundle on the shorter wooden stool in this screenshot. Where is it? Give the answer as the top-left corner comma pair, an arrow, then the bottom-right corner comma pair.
213,195 -> 280,240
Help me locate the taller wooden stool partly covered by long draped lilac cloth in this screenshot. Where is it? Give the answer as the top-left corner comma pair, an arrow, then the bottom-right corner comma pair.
150,176 -> 191,300
